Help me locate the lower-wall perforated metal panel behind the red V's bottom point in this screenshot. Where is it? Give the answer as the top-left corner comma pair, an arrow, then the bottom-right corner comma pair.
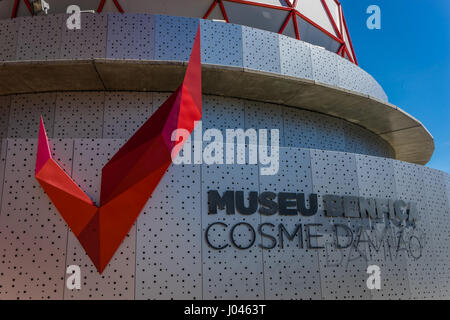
64,139 -> 136,299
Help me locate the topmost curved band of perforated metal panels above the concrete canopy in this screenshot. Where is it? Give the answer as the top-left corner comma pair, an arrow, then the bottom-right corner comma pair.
0,14 -> 387,101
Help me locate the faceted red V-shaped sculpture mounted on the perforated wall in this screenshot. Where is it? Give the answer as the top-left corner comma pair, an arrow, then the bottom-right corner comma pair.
35,28 -> 202,273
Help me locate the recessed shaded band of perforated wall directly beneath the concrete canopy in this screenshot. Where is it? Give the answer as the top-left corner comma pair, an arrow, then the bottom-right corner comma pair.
0,91 -> 395,158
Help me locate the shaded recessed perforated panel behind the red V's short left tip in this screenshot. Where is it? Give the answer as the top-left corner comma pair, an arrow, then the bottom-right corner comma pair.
8,93 -> 56,138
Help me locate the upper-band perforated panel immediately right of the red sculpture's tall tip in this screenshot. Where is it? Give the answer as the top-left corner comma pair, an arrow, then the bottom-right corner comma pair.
200,20 -> 243,67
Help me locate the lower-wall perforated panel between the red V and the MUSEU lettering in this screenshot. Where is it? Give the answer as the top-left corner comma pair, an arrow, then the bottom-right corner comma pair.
136,165 -> 202,299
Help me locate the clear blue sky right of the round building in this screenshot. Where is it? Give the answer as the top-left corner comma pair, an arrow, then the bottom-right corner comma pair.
340,0 -> 450,173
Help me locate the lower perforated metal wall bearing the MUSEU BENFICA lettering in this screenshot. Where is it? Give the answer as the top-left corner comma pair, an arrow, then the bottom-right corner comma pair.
0,123 -> 450,300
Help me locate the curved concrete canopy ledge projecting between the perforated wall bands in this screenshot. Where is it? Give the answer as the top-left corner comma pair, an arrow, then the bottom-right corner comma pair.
0,59 -> 434,165
